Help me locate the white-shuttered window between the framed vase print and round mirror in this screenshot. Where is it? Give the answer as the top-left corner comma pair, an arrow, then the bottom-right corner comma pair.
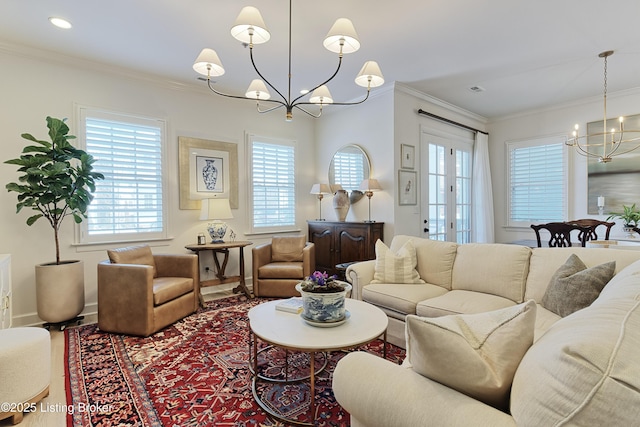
248,135 -> 296,233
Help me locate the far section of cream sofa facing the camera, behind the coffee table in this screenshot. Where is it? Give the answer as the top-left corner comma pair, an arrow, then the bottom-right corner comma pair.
346,235 -> 640,348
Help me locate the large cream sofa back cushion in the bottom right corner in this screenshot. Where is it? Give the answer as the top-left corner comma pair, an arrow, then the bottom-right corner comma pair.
511,296 -> 640,426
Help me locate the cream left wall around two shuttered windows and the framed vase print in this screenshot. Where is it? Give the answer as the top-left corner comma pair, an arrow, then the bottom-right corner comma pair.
0,45 -> 316,326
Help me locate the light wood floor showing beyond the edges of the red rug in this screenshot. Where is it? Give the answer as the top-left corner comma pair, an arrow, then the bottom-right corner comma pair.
0,290 -> 234,427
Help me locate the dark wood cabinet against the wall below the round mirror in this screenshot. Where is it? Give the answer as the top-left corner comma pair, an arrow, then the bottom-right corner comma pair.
307,221 -> 384,274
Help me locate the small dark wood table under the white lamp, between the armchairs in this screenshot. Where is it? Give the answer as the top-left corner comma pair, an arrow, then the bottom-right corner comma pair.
185,241 -> 253,305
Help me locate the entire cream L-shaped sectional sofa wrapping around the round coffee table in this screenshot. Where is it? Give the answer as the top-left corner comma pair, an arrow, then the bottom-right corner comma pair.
333,236 -> 640,427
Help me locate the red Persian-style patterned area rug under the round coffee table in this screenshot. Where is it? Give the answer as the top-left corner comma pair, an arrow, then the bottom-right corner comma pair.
65,296 -> 404,427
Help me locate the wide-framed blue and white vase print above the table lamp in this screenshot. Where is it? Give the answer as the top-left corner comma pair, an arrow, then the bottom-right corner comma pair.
178,136 -> 238,209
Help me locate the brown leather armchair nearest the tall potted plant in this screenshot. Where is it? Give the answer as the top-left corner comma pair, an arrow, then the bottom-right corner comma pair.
98,245 -> 200,337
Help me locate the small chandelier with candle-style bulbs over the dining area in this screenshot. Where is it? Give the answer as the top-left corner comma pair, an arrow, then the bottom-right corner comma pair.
566,50 -> 640,163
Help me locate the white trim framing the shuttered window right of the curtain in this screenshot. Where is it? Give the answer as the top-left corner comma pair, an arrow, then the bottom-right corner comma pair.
505,134 -> 570,229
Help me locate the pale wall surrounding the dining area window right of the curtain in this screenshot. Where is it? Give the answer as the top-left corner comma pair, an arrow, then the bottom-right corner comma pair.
488,89 -> 640,243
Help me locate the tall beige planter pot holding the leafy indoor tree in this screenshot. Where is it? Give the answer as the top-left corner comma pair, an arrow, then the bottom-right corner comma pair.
36,261 -> 84,323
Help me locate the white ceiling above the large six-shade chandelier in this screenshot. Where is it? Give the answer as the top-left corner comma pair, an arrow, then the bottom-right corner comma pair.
0,0 -> 640,119
